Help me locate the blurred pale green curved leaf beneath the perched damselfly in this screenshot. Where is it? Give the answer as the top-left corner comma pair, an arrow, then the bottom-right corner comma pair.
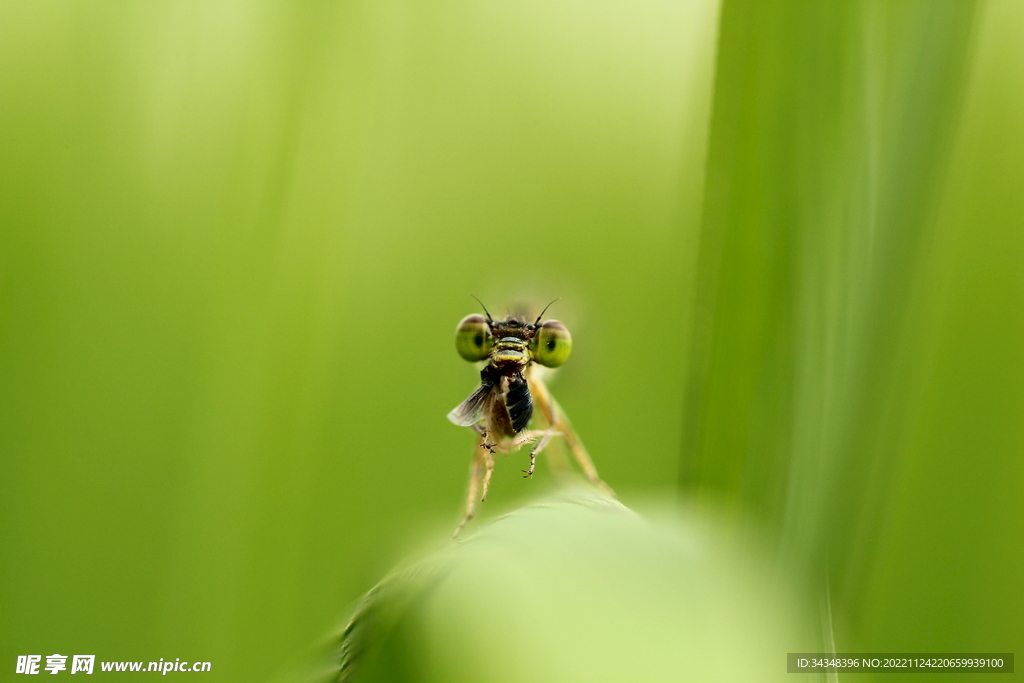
331,493 -> 808,682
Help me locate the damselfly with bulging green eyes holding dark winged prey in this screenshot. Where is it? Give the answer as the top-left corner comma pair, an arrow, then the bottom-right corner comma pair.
447,299 -> 614,536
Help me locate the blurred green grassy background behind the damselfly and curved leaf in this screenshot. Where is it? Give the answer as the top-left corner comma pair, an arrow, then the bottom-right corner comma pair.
0,0 -> 1024,681
